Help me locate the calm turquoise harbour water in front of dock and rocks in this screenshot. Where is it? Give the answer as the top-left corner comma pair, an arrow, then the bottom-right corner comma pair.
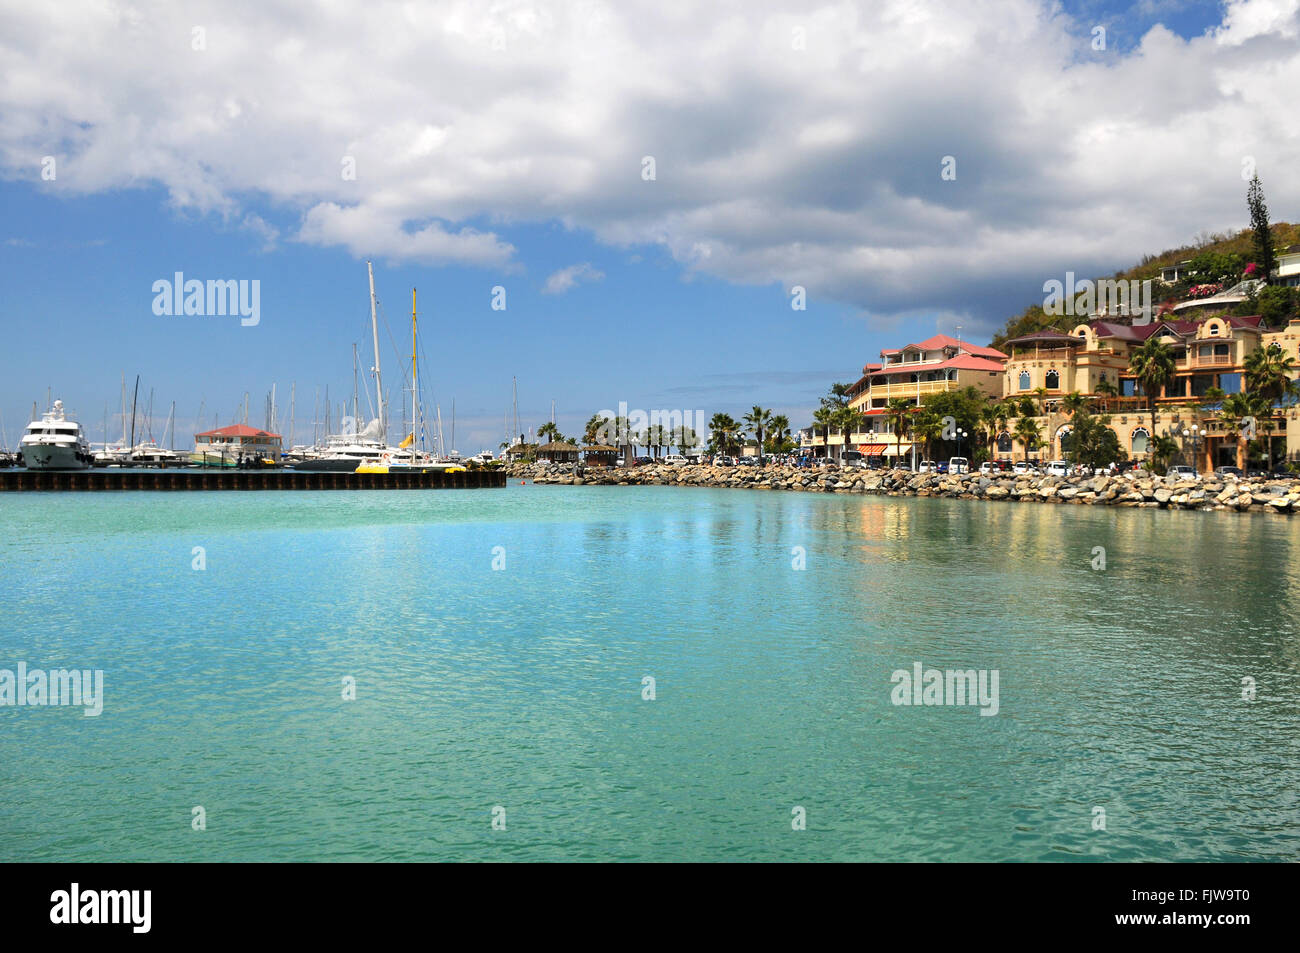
0,485 -> 1300,861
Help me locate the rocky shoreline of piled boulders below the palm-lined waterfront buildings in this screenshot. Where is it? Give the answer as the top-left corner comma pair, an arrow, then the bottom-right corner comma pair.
506,463 -> 1300,514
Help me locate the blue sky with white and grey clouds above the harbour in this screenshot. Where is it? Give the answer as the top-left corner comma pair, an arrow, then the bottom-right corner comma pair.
0,0 -> 1300,452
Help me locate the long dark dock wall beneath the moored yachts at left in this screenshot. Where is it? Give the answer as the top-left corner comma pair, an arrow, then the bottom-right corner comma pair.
0,467 -> 506,493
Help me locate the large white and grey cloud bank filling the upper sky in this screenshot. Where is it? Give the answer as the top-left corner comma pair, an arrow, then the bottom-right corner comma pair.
0,0 -> 1300,330
